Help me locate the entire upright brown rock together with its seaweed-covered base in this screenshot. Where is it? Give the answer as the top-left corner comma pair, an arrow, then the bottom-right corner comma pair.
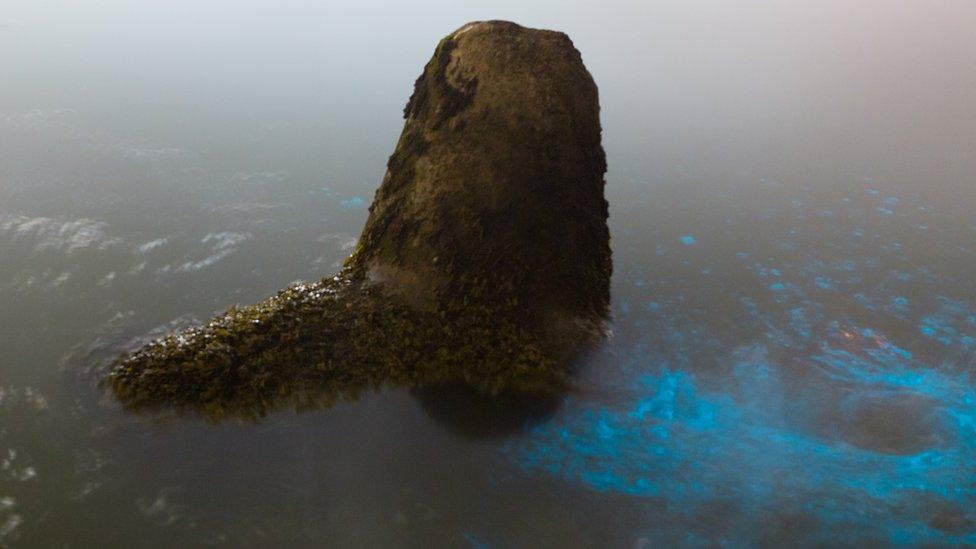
109,21 -> 611,419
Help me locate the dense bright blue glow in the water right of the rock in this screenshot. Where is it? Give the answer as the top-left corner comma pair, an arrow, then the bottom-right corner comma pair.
510,330 -> 976,544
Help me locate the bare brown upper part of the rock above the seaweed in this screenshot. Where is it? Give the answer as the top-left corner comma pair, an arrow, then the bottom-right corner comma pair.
357,21 -> 611,320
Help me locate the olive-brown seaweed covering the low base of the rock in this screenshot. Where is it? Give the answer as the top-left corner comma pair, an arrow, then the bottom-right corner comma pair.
107,256 -> 567,421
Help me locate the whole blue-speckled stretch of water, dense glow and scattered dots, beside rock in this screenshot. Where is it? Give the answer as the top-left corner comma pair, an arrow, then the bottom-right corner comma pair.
503,179 -> 976,546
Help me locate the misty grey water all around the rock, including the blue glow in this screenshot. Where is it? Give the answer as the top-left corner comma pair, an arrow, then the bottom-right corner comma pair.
0,2 -> 976,547
